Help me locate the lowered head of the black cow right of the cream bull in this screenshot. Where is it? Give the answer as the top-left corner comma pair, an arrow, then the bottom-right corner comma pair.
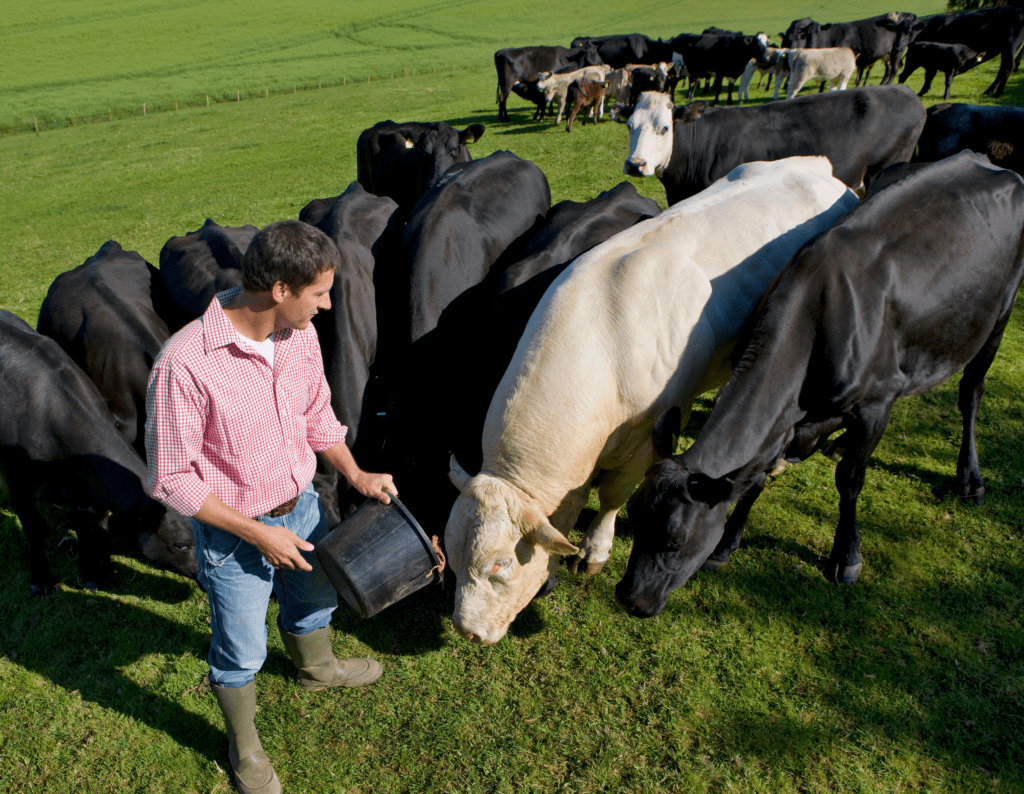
615,458 -> 732,618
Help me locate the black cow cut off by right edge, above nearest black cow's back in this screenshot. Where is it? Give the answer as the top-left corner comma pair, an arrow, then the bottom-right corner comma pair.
913,102 -> 1024,175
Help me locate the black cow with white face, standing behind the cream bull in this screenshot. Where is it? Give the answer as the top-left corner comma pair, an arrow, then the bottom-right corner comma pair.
623,85 -> 925,204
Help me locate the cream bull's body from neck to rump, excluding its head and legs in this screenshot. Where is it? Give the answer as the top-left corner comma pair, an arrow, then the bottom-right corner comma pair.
483,159 -> 856,493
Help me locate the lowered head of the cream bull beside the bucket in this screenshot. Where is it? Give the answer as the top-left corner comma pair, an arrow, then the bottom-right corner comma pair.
444,456 -> 579,645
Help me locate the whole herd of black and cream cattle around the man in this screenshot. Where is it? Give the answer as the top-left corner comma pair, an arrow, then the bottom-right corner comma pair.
6,5 -> 1024,643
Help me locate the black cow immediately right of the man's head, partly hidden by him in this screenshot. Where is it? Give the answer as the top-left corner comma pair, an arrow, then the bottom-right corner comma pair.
299,182 -> 400,523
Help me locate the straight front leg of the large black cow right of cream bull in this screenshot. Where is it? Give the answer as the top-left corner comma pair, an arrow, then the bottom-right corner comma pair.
824,403 -> 892,584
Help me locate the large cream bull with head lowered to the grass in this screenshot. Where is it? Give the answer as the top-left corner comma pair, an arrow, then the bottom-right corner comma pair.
444,158 -> 857,644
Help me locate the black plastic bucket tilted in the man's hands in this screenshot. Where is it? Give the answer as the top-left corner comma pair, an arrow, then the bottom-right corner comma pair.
316,496 -> 443,618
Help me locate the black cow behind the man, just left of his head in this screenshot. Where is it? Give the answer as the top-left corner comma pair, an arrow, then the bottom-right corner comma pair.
160,218 -> 259,325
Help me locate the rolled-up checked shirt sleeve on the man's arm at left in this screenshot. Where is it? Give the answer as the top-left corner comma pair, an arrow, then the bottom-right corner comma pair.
145,360 -> 210,516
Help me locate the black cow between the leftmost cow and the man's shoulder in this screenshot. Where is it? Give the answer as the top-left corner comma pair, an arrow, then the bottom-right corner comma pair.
36,240 -> 171,459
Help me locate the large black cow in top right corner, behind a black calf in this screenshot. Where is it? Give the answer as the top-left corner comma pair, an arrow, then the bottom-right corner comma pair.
897,5 -> 1024,96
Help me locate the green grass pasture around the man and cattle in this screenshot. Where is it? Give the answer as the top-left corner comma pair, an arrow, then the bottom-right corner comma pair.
0,0 -> 1024,794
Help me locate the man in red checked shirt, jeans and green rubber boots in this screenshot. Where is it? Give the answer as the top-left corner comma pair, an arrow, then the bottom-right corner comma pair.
145,220 -> 397,794
